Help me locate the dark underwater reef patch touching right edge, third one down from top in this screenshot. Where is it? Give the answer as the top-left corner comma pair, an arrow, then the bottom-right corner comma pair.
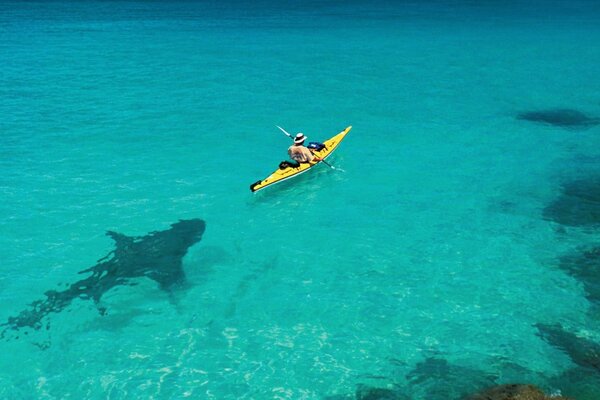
559,246 -> 600,304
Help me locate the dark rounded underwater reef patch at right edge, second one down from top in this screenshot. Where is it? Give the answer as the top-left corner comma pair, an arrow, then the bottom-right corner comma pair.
543,176 -> 600,226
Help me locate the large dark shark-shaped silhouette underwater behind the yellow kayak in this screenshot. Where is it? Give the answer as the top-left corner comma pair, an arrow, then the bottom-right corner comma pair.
0,219 -> 205,338
